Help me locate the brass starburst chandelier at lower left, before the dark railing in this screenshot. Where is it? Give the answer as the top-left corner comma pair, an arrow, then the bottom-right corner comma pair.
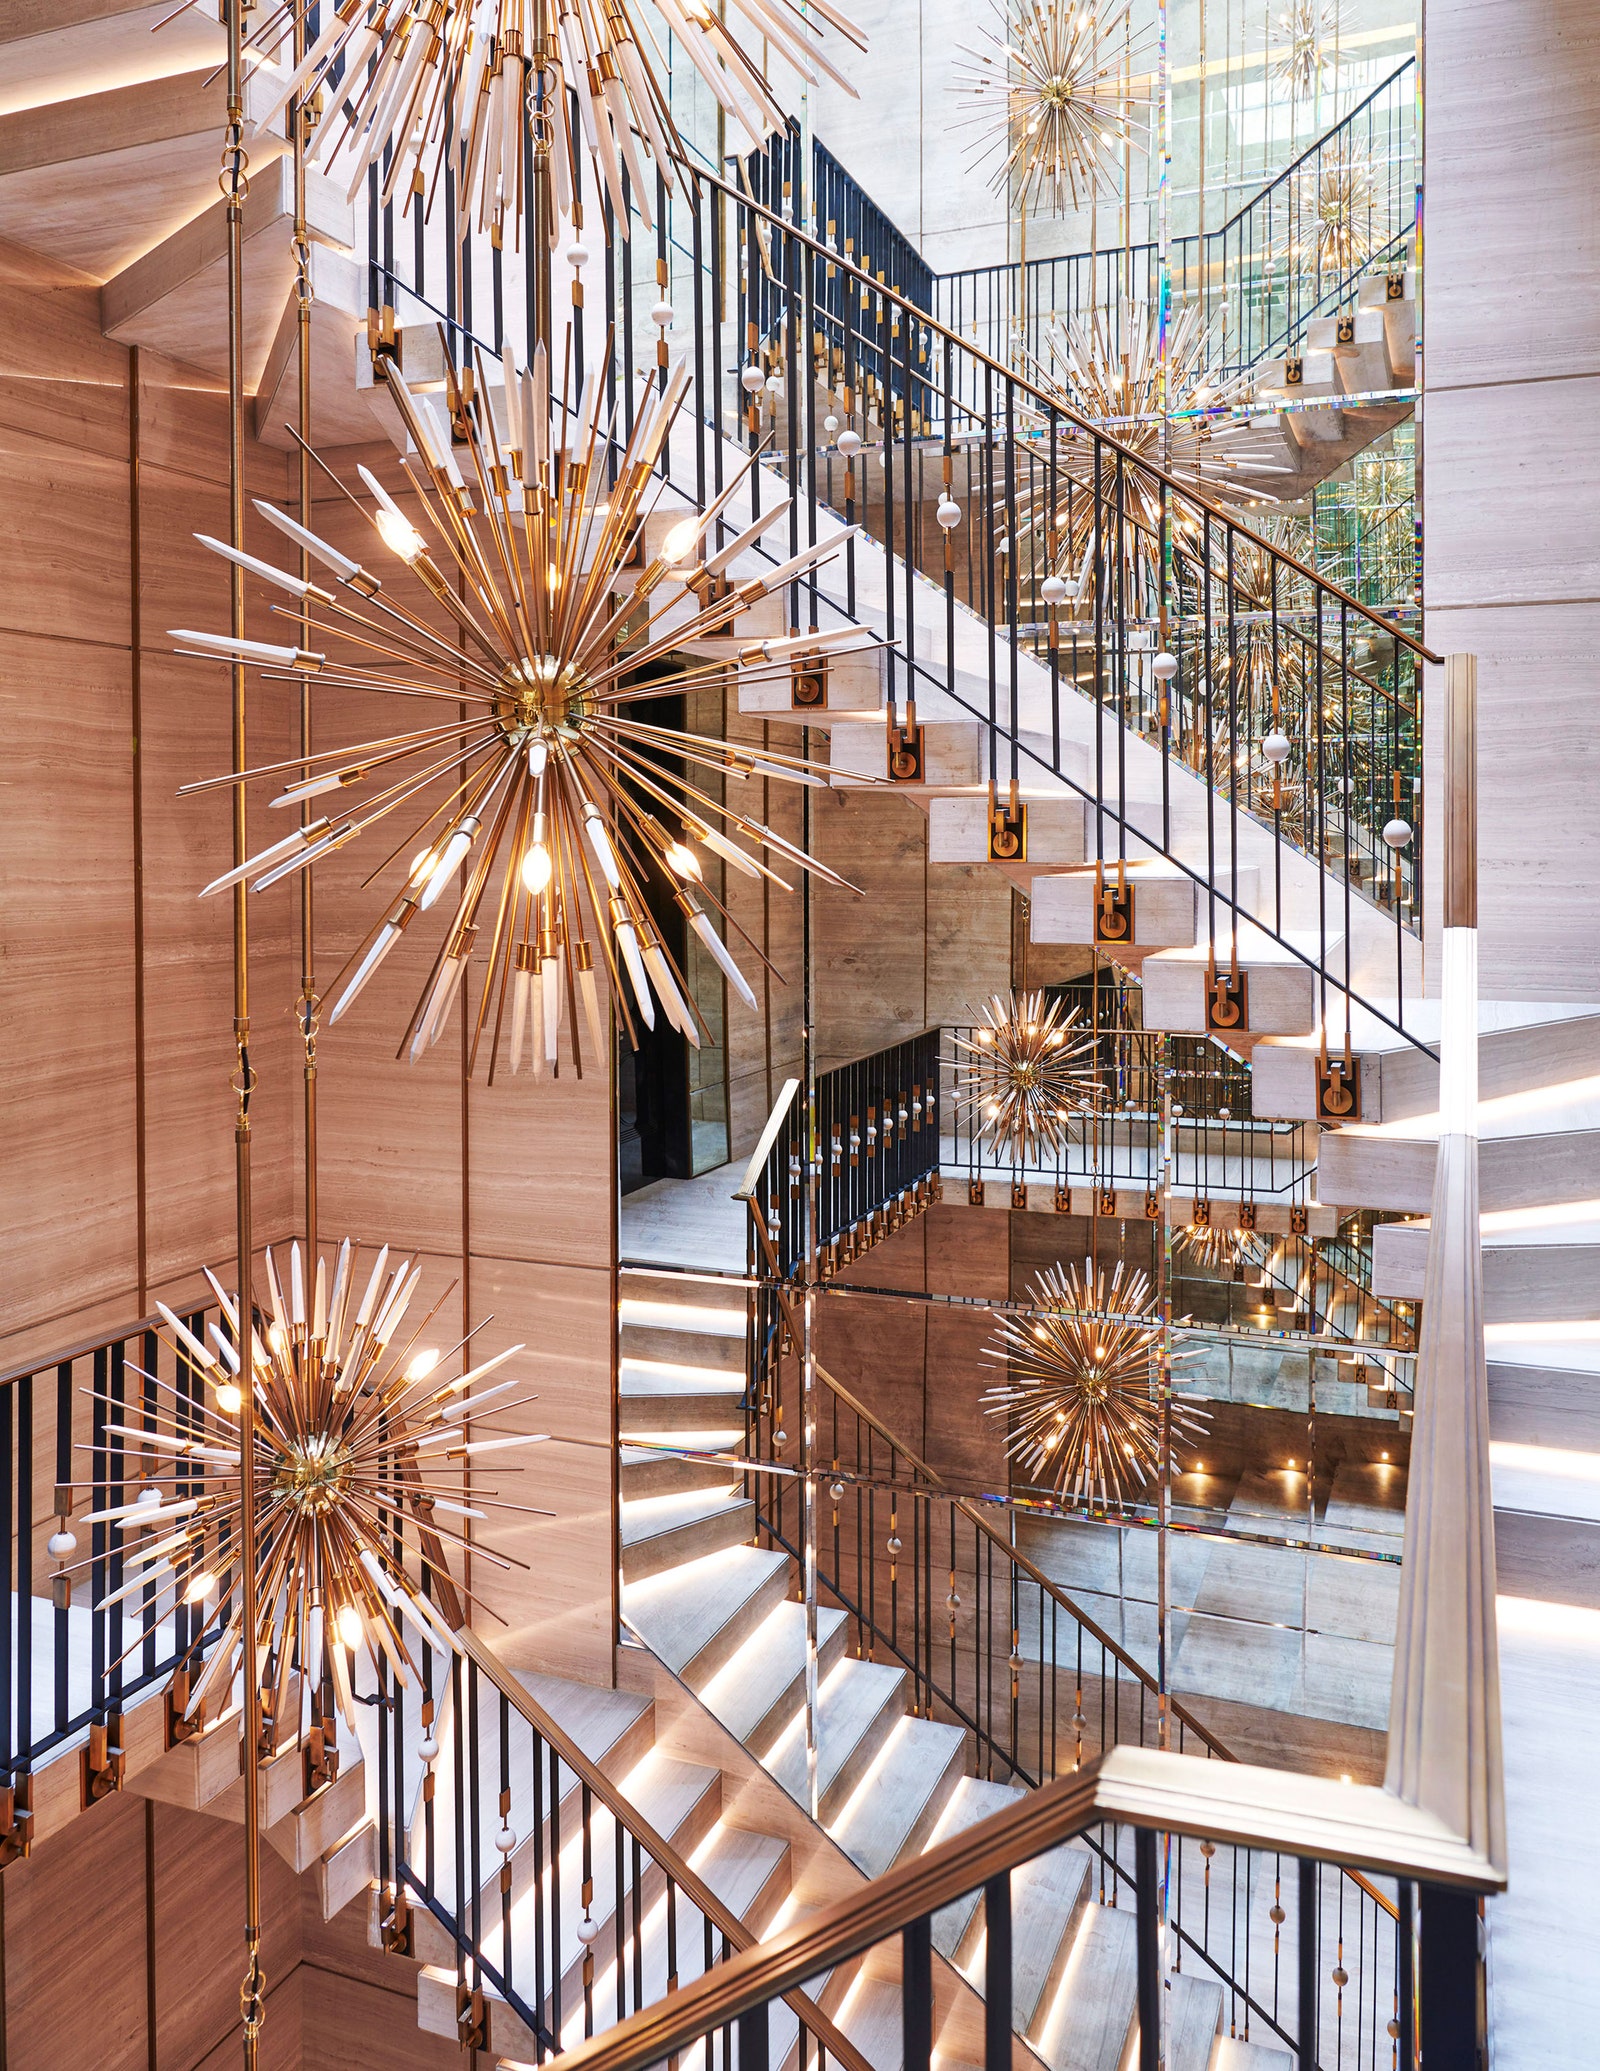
81,1241 -> 549,1731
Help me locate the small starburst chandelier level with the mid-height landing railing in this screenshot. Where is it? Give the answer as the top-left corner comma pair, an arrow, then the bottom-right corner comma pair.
954,992 -> 1105,1166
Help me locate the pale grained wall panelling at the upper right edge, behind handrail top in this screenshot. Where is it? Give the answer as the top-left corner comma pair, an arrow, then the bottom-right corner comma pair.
1422,0 -> 1600,1000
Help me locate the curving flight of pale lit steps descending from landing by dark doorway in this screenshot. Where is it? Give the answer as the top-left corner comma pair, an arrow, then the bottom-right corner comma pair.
619,1267 -> 1290,2071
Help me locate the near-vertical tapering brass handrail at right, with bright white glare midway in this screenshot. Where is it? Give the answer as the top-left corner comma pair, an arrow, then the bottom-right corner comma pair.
1385,654 -> 1505,1868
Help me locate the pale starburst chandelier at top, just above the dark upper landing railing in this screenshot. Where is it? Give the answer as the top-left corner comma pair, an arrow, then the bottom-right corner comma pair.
954,0 -> 1149,215
